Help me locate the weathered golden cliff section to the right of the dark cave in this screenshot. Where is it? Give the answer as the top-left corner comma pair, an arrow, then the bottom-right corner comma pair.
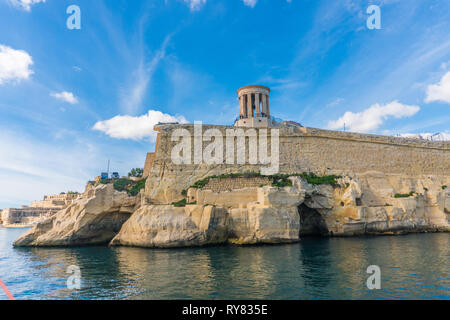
320,172 -> 450,236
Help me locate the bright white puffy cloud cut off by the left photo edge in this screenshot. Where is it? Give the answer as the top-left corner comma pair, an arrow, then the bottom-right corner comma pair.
0,45 -> 33,84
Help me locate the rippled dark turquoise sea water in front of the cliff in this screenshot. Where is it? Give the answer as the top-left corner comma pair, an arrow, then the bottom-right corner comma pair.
0,228 -> 450,299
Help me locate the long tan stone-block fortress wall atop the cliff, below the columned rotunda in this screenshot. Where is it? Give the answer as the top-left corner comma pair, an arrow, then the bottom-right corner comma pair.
146,125 -> 450,203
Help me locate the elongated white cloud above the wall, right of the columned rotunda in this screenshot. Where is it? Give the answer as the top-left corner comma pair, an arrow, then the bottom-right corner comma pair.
328,101 -> 420,132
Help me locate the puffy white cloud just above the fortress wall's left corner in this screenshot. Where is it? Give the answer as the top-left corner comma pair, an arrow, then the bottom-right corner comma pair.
92,110 -> 187,141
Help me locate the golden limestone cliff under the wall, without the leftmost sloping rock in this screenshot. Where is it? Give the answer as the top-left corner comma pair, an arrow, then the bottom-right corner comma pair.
107,172 -> 450,247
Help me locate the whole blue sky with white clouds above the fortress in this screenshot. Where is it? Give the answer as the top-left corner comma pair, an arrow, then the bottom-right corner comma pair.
0,0 -> 450,208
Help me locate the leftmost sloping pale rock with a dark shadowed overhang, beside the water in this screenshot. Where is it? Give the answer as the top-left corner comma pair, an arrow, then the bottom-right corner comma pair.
14,184 -> 136,246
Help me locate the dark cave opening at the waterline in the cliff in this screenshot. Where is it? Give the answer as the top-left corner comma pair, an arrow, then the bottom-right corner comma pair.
298,203 -> 328,236
